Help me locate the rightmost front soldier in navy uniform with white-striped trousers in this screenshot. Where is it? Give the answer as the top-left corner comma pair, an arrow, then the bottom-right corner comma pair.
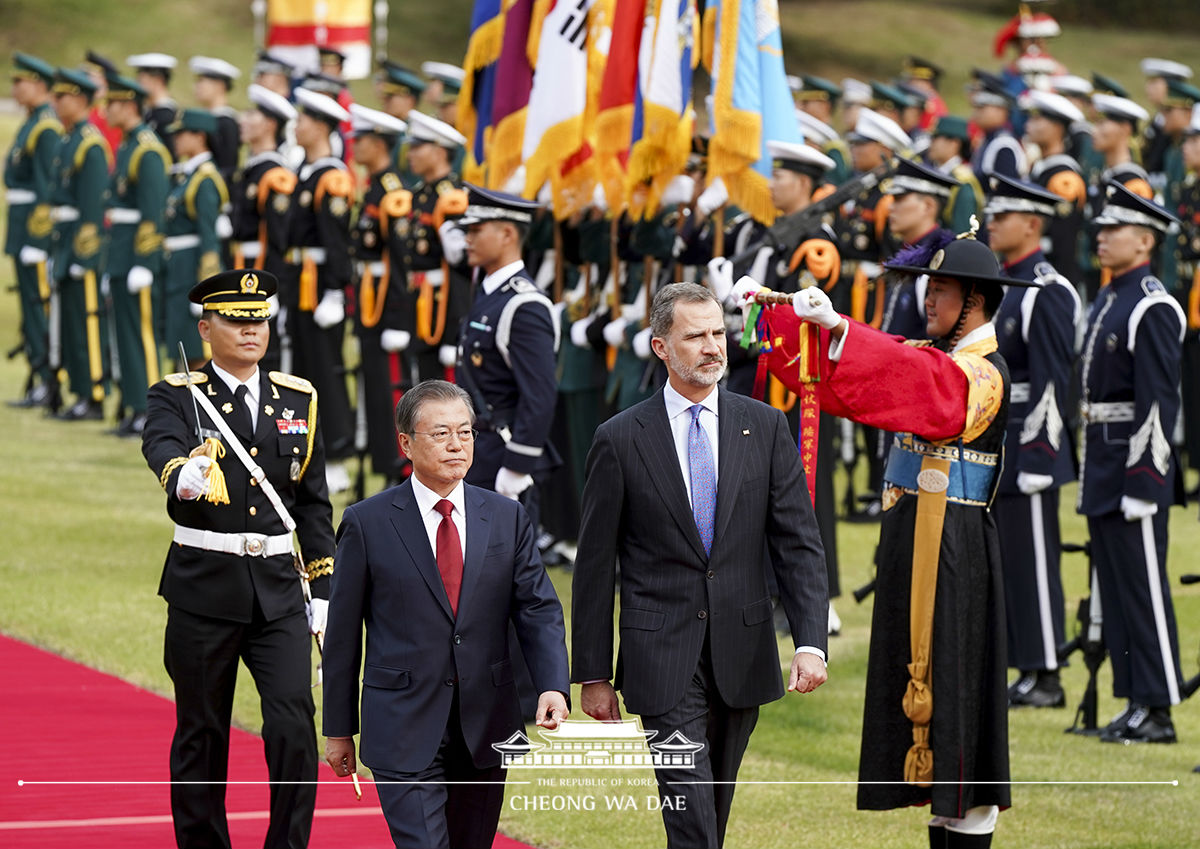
1078,185 -> 1186,742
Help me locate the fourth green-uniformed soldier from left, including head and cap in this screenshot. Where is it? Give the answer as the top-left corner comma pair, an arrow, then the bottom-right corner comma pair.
161,109 -> 229,367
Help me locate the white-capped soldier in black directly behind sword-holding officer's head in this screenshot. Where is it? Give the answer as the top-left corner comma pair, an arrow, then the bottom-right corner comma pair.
229,84 -> 296,273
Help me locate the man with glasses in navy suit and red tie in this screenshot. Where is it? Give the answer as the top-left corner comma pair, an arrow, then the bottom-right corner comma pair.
324,380 -> 570,849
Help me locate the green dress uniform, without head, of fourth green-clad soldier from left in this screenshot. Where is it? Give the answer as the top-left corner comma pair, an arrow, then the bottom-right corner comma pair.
158,152 -> 229,360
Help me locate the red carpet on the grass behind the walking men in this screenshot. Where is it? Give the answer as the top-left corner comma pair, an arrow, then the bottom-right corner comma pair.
0,636 -> 524,849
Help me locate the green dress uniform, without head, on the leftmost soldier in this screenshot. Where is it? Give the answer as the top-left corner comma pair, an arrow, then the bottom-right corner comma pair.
4,94 -> 62,395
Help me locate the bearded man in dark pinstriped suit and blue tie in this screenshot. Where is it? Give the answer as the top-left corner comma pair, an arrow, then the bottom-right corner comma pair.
571,283 -> 829,849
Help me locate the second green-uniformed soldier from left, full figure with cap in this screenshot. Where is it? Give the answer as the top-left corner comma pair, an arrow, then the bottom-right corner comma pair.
50,68 -> 113,421
